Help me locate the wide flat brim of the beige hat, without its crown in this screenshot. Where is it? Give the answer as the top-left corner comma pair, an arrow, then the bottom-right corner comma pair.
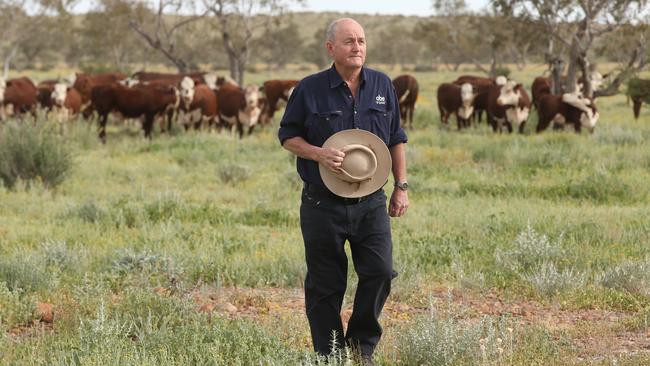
318,129 -> 393,198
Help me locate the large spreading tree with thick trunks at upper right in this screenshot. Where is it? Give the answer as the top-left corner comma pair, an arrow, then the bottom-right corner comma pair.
492,0 -> 647,98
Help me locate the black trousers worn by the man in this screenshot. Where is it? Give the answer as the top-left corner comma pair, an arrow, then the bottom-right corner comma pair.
300,185 -> 395,355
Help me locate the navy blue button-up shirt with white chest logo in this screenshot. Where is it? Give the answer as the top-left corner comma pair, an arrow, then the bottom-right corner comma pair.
278,65 -> 407,186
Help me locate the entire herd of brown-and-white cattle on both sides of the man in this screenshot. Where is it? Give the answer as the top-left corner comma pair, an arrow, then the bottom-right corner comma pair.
0,71 -> 650,142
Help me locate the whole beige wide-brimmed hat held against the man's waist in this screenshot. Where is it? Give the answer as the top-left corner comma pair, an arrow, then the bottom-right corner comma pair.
318,129 -> 392,198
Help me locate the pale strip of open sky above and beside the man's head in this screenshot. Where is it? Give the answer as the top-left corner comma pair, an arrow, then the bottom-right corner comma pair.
291,0 -> 488,16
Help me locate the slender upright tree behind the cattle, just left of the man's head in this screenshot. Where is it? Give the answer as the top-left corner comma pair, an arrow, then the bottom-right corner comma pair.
203,0 -> 301,85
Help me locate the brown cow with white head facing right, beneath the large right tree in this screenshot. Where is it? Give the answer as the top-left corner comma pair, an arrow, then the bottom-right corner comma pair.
537,94 -> 599,133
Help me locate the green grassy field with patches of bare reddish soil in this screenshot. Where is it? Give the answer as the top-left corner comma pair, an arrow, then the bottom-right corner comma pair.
0,68 -> 650,365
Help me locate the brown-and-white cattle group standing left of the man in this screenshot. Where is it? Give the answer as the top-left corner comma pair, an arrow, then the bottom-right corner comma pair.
0,71 -> 298,142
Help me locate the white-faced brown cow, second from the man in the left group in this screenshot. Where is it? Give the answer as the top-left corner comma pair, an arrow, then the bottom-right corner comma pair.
217,83 -> 261,138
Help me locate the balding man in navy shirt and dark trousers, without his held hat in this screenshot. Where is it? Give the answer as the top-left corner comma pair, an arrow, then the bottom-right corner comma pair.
278,18 -> 409,364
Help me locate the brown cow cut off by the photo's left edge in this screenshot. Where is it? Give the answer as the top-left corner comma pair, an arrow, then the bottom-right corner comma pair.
0,77 -> 38,119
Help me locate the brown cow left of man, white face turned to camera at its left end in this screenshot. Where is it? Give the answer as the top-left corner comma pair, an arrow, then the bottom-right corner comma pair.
179,77 -> 217,130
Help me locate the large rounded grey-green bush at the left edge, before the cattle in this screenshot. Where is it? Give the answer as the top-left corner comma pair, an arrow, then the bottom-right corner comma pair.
0,121 -> 72,188
